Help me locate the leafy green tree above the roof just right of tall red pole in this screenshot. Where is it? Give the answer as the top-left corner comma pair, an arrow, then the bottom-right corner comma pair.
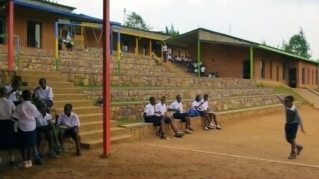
123,12 -> 152,30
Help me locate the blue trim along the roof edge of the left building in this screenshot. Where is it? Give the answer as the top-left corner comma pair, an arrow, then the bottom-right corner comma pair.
12,0 -> 121,26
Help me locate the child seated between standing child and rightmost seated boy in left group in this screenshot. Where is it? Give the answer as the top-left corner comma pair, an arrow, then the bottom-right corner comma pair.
36,103 -> 60,158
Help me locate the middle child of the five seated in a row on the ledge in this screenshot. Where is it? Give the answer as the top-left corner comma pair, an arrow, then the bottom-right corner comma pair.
168,95 -> 194,134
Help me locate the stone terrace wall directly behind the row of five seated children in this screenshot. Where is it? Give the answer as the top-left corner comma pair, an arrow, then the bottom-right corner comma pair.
111,95 -> 279,120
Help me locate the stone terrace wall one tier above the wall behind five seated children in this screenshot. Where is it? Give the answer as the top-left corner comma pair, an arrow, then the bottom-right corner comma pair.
80,88 -> 273,102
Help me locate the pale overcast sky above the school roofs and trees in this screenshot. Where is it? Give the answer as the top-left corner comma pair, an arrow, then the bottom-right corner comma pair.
58,0 -> 319,59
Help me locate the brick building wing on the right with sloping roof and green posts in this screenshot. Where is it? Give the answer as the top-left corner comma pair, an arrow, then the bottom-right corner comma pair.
166,28 -> 318,88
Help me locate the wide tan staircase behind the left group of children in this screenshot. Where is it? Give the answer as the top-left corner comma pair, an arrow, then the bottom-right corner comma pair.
15,71 -> 132,148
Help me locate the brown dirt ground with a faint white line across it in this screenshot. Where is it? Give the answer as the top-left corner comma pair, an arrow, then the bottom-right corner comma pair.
0,106 -> 319,179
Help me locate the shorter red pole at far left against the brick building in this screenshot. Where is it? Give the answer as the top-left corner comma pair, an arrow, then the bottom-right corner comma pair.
7,0 -> 14,69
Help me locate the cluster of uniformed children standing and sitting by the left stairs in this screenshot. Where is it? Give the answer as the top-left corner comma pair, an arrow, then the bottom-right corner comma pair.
0,78 -> 81,168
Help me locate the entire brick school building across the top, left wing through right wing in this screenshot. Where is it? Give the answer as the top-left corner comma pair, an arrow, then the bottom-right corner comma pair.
0,0 -> 318,88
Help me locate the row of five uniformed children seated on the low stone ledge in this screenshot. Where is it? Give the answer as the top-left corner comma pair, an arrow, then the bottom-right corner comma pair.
143,94 -> 221,139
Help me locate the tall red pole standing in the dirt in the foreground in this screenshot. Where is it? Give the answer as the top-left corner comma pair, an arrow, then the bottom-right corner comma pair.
103,0 -> 111,156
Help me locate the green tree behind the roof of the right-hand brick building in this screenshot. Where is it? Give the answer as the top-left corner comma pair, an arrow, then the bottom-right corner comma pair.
282,27 -> 311,59
